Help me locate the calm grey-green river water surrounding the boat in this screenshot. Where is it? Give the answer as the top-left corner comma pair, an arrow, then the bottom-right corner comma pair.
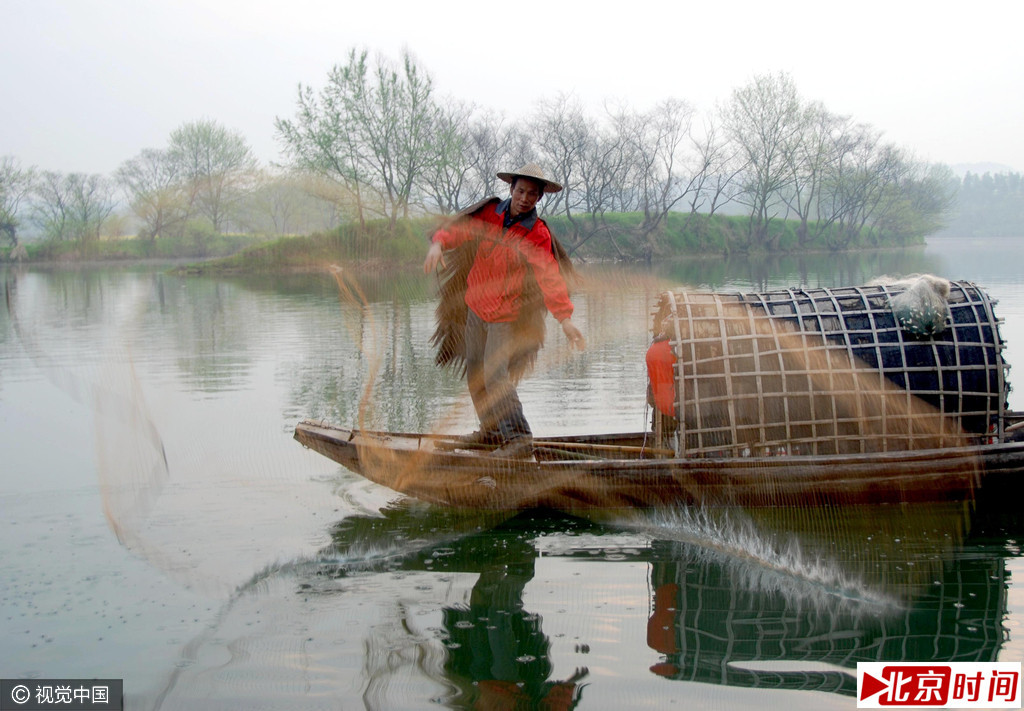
0,239 -> 1024,709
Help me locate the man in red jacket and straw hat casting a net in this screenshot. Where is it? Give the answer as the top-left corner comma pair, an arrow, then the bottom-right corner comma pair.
423,163 -> 585,459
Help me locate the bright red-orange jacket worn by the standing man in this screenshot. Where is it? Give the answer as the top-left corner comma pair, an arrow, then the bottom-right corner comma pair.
433,200 -> 572,324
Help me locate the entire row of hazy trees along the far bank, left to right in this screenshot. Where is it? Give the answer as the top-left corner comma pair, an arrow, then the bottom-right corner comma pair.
0,50 -> 952,259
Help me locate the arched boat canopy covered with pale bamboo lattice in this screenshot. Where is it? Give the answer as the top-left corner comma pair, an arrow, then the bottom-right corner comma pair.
653,278 -> 1009,457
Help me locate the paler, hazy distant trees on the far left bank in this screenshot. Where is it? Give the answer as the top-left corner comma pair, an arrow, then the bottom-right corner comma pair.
0,119 -> 341,253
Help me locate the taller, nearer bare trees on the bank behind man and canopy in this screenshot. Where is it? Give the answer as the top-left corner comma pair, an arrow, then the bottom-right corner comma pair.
276,50 -> 952,258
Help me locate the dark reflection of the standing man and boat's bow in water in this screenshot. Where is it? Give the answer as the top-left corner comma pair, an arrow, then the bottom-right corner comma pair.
319,502 -> 592,711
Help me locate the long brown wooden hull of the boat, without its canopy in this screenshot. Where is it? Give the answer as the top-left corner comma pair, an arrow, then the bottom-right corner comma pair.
295,420 -> 1024,512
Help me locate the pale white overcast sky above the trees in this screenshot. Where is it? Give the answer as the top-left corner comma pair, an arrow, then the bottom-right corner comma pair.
0,0 -> 1024,173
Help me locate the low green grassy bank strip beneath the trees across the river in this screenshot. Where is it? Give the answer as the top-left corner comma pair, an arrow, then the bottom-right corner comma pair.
0,213 -> 924,275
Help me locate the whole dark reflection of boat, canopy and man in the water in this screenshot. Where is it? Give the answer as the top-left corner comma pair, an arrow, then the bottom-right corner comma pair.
322,497 -> 1008,708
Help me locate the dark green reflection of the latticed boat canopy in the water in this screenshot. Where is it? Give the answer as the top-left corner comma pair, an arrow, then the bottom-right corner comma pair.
647,506 -> 1008,695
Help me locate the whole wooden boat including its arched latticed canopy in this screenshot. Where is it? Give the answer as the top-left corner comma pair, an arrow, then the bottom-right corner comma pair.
295,283 -> 1024,512
